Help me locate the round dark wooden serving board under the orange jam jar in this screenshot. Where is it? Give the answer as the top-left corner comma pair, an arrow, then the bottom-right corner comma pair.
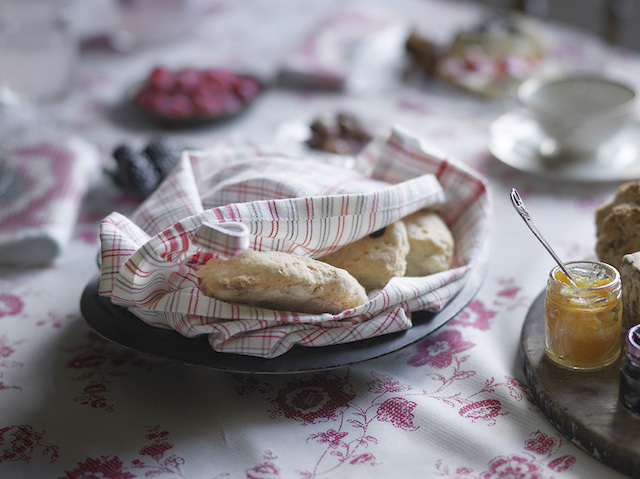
520,291 -> 640,478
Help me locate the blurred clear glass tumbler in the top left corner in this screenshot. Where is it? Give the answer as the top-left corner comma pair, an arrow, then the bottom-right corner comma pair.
0,0 -> 78,106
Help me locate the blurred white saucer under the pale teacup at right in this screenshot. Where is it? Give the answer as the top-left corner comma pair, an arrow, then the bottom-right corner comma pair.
489,110 -> 640,183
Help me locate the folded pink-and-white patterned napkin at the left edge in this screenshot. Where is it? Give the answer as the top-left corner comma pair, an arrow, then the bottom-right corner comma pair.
0,137 -> 99,266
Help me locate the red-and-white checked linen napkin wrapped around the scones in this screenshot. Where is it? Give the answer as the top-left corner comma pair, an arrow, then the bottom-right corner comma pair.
99,130 -> 490,358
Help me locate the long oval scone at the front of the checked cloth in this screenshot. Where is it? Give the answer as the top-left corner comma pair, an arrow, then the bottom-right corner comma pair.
197,250 -> 368,314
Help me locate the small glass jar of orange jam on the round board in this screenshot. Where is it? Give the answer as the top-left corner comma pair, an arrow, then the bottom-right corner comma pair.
544,261 -> 622,369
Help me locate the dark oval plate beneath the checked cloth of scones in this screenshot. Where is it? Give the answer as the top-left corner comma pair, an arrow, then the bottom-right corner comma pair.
80,248 -> 487,374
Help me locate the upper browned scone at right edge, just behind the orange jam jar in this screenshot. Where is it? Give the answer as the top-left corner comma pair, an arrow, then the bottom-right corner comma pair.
596,203 -> 640,269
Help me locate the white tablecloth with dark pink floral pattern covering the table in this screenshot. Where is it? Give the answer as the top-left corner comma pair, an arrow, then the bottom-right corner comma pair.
0,0 -> 640,479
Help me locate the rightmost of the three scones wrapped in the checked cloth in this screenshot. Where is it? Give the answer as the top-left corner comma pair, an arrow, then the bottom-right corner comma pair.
403,210 -> 455,276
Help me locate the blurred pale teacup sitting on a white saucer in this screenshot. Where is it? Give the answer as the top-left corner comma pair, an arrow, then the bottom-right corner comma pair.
517,75 -> 636,158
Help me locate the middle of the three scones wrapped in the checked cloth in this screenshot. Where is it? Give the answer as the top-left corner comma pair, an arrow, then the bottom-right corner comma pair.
319,221 -> 409,291
